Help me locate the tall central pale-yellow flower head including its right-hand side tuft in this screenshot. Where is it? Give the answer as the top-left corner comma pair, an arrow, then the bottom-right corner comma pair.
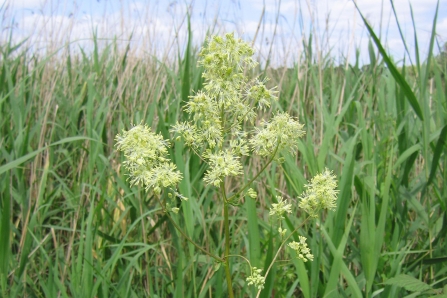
171,34 -> 304,186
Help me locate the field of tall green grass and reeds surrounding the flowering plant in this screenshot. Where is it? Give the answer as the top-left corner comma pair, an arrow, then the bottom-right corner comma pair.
0,2 -> 447,297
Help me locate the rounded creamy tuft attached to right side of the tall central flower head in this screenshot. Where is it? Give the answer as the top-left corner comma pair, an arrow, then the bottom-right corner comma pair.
250,112 -> 305,156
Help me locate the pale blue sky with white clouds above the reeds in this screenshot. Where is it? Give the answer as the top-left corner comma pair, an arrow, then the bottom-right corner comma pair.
0,0 -> 447,64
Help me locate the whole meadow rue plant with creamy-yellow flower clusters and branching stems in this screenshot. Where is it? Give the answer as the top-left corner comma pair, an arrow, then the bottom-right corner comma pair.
116,34 -> 337,297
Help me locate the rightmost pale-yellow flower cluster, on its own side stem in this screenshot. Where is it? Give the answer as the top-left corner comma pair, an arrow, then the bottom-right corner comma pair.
299,169 -> 338,217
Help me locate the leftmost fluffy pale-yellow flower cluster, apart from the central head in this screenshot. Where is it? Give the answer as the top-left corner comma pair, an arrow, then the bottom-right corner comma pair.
115,125 -> 182,193
